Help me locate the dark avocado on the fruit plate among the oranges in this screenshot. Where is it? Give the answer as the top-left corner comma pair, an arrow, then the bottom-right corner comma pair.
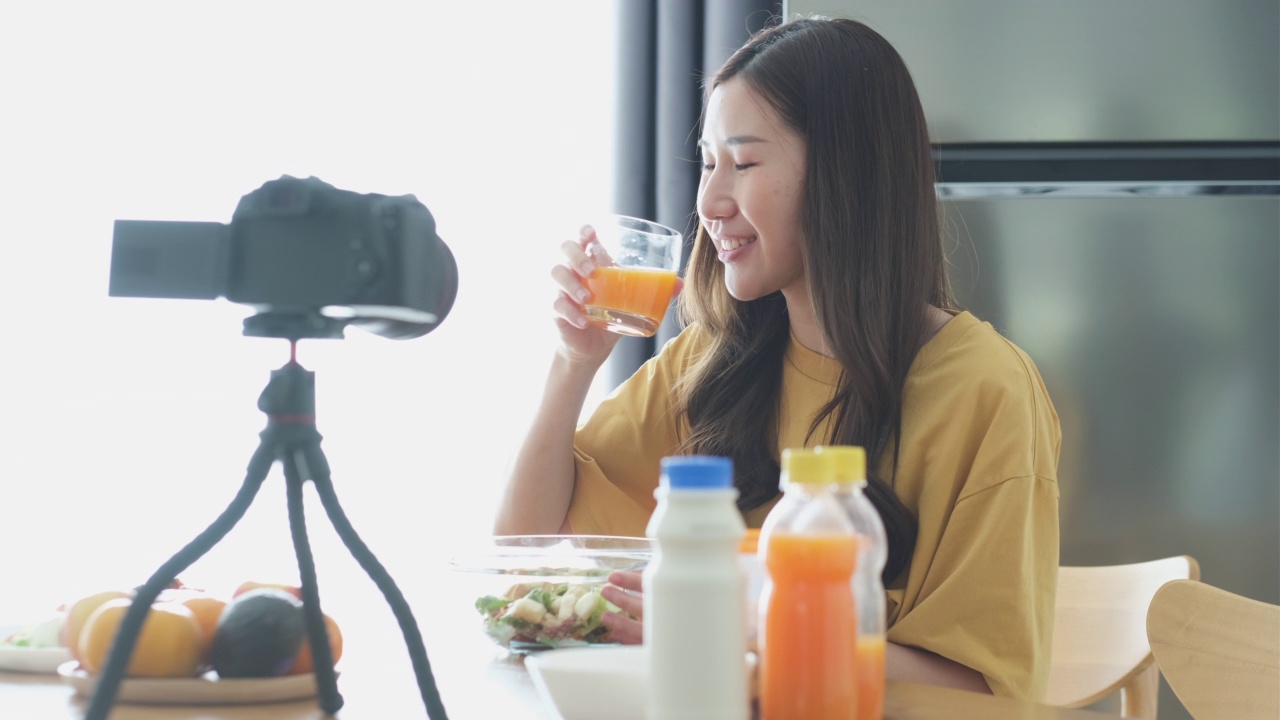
209,588 -> 306,678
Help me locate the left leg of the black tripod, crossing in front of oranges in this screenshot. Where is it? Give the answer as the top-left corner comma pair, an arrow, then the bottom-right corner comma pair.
84,430 -> 275,720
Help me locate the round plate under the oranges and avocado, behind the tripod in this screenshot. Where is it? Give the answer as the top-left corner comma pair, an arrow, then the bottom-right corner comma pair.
58,661 -> 335,705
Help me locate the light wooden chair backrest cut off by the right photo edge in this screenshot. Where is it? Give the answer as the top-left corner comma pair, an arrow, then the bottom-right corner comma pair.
1147,580 -> 1280,720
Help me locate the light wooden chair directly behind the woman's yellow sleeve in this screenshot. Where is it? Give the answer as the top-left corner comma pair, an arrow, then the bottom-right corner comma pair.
1044,555 -> 1199,720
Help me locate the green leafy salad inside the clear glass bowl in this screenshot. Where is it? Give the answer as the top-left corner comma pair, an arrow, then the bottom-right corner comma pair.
476,583 -> 621,647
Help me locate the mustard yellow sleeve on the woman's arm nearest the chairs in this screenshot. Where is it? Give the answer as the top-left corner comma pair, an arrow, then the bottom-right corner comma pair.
881,316 -> 1061,701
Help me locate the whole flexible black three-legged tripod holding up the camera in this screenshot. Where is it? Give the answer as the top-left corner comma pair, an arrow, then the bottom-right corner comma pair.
84,340 -> 445,720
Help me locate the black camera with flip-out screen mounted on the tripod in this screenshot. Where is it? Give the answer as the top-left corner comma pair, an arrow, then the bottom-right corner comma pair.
109,176 -> 457,340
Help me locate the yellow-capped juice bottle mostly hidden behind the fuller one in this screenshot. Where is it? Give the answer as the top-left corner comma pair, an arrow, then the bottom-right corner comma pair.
814,446 -> 888,720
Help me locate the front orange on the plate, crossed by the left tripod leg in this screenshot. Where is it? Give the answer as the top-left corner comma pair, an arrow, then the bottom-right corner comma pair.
79,600 -> 204,678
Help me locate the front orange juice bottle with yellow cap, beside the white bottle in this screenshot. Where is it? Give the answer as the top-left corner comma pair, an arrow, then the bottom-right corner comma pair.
759,450 -> 858,720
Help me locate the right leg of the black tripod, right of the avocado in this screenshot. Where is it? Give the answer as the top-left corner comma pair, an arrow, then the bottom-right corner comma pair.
303,445 -> 447,720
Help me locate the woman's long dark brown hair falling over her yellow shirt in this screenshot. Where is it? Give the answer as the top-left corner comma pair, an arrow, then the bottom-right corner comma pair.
678,18 -> 955,582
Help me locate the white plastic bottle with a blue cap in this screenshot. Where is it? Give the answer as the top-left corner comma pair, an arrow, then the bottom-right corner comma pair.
644,456 -> 750,720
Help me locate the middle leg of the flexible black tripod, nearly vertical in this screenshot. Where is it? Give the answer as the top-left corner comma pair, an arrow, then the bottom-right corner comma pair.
280,451 -> 343,715
